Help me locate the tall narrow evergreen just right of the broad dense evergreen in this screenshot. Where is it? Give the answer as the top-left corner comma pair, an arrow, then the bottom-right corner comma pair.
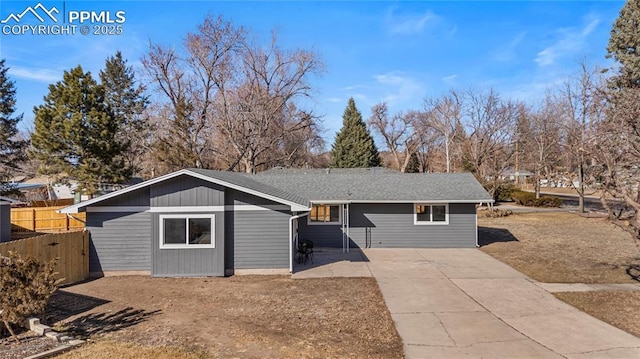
100,51 -> 149,174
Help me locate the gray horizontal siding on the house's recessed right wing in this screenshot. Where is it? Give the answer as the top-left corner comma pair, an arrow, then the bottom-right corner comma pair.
298,203 -> 477,248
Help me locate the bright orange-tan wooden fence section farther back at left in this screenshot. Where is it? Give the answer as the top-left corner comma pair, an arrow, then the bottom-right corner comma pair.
11,206 -> 86,232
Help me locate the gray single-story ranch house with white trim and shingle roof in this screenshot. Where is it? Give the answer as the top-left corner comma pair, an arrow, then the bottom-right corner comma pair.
60,168 -> 492,276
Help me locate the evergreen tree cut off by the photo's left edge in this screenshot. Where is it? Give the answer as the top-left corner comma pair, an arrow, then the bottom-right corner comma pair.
0,59 -> 27,194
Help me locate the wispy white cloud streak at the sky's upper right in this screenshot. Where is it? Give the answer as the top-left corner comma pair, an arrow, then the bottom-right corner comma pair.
534,15 -> 600,66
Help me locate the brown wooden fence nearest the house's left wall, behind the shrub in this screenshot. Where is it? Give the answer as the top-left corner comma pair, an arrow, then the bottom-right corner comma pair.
0,231 -> 89,284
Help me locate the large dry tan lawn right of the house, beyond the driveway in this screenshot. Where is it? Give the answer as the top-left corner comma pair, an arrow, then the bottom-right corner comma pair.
478,212 -> 640,283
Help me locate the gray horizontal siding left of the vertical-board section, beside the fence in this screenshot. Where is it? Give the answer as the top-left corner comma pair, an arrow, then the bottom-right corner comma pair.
86,212 -> 151,272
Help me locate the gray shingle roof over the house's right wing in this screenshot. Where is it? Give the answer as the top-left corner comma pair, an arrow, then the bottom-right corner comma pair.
252,168 -> 492,202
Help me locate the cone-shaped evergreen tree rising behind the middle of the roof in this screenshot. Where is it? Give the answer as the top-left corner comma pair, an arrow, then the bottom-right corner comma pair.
331,98 -> 380,168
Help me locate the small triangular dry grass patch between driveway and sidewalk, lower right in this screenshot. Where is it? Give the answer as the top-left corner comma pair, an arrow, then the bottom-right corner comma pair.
555,291 -> 640,337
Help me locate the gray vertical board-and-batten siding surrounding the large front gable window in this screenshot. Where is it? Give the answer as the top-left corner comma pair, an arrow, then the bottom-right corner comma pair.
150,175 -> 225,277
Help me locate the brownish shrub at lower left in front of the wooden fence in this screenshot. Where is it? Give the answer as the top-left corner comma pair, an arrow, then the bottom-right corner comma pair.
0,252 -> 58,341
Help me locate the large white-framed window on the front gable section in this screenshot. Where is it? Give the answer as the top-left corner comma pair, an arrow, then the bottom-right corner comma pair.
159,214 -> 216,249
